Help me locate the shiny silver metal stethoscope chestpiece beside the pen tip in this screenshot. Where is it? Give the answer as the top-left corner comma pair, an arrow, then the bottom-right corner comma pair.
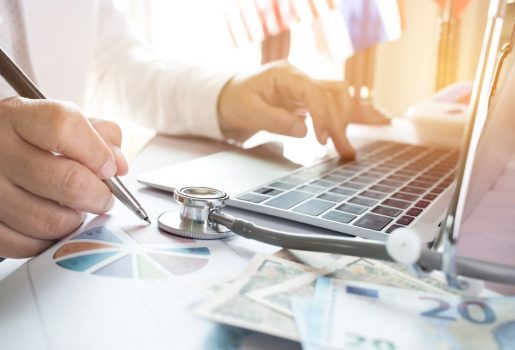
158,187 -> 233,239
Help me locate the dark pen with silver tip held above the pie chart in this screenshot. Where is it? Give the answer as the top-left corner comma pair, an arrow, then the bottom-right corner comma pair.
0,48 -> 151,224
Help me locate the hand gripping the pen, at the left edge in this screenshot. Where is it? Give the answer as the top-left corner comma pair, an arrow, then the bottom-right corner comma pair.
0,97 -> 127,258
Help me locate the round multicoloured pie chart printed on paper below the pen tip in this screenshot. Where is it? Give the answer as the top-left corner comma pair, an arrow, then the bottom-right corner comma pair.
53,226 -> 211,279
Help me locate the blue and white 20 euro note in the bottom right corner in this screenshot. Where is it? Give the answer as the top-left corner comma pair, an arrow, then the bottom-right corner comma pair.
315,278 -> 515,350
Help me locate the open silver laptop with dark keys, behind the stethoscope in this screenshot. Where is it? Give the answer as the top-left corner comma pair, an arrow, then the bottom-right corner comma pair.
138,0 -> 515,246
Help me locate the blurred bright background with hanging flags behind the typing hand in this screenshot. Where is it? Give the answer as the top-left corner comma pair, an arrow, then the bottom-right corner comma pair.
115,0 -> 500,115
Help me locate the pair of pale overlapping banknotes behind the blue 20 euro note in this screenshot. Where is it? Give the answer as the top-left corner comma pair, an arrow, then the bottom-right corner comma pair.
194,252 -> 460,344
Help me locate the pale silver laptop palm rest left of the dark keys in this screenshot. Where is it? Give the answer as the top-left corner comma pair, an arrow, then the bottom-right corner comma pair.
138,144 -> 300,196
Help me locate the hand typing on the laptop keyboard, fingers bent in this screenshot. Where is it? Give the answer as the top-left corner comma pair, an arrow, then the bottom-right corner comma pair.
218,62 -> 388,158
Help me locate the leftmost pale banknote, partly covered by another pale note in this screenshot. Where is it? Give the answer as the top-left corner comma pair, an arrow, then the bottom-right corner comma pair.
194,256 -> 313,340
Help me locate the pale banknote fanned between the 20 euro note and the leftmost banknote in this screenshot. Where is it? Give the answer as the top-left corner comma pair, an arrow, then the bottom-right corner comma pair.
247,255 -> 449,317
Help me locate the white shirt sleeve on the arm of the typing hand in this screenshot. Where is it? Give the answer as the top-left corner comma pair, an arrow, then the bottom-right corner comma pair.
93,1 -> 236,139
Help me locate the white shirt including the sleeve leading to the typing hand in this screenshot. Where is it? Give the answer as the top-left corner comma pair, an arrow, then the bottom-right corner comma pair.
0,0 -> 234,139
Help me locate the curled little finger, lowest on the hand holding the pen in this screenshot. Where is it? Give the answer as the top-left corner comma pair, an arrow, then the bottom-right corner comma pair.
0,222 -> 53,259
